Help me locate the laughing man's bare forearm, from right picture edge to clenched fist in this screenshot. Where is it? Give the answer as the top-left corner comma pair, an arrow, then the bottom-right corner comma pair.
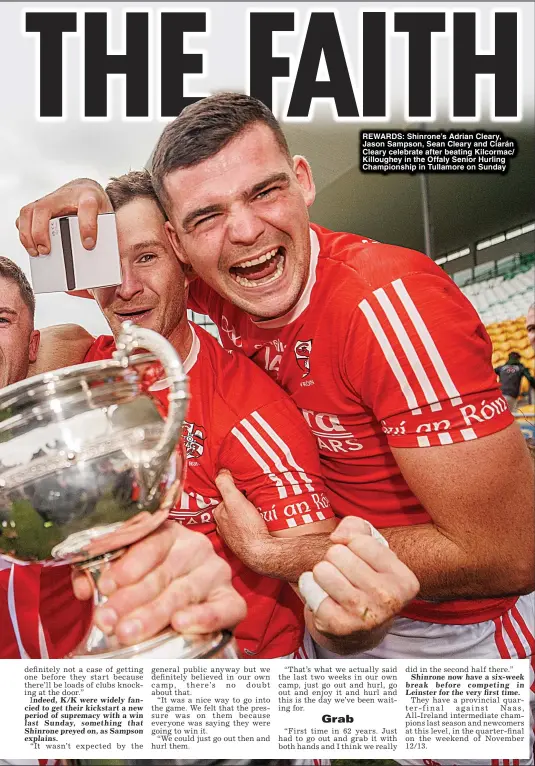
381,524 -> 535,601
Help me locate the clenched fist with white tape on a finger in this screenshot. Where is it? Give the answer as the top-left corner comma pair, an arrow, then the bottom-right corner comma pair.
301,516 -> 420,654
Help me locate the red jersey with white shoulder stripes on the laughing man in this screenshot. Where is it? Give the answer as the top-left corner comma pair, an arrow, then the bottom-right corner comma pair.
189,225 -> 515,623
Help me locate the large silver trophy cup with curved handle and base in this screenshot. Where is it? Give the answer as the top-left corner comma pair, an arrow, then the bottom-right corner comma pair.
0,322 -> 236,659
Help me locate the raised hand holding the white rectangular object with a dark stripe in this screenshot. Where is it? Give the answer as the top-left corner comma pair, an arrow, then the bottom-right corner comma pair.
16,178 -> 113,257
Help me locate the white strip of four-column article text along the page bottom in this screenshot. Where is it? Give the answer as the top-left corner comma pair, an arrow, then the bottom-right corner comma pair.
2,660 -> 530,762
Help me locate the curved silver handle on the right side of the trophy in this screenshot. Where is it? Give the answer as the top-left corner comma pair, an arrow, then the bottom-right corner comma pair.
113,322 -> 189,494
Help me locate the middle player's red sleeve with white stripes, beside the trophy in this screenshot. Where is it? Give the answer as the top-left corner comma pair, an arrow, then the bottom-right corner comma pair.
218,398 -> 334,532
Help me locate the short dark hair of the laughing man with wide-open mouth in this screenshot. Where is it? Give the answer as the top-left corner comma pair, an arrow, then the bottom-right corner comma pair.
152,93 -> 291,209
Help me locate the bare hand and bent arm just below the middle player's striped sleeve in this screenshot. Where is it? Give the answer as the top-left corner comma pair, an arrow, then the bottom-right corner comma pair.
214,470 -> 336,583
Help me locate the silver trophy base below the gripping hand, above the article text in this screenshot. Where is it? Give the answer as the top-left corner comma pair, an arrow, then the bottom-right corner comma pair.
69,628 -> 238,660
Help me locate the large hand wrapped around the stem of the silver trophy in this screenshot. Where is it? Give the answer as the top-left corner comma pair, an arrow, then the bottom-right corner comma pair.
73,521 -> 246,645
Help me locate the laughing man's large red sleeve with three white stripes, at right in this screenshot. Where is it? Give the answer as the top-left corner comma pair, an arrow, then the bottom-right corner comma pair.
345,272 -> 513,447
